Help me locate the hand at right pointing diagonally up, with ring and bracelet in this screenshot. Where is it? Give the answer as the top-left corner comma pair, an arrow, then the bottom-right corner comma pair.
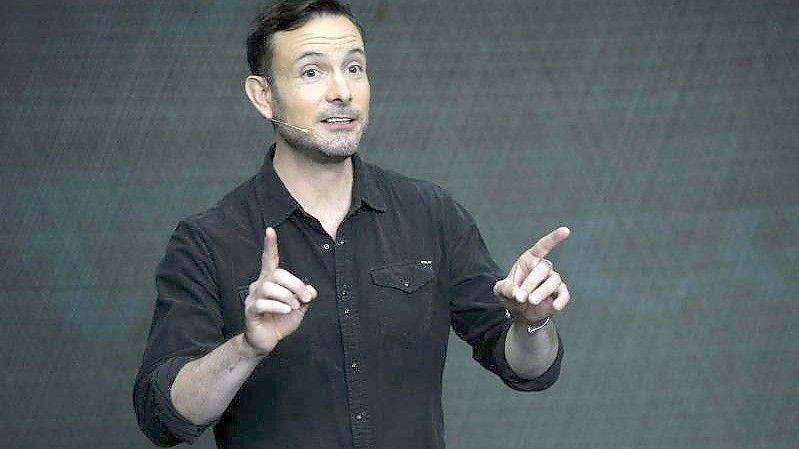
494,227 -> 570,322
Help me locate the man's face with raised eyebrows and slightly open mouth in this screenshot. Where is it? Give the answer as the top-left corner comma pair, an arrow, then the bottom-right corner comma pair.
272,15 -> 370,160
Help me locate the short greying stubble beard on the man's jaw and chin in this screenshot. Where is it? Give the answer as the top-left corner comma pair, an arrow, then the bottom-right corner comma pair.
272,96 -> 369,163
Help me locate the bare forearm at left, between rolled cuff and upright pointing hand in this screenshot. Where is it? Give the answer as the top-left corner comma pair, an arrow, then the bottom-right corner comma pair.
170,334 -> 263,425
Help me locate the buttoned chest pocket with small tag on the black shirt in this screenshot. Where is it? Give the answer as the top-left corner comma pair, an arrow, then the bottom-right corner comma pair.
370,261 -> 436,349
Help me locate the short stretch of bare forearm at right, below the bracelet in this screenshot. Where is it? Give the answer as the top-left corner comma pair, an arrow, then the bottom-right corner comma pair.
505,320 -> 558,379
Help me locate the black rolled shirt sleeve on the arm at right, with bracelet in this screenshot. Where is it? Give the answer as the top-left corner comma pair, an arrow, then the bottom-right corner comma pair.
444,194 -> 563,391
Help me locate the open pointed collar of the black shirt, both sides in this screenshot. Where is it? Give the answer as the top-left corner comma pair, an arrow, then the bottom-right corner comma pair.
255,144 -> 386,227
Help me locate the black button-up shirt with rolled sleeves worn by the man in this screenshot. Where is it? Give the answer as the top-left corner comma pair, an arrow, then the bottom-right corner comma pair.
134,147 -> 562,448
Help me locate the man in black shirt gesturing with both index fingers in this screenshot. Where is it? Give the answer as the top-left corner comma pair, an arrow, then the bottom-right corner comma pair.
134,0 -> 569,448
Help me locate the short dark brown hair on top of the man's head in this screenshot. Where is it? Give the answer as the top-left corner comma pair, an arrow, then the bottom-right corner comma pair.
247,0 -> 366,84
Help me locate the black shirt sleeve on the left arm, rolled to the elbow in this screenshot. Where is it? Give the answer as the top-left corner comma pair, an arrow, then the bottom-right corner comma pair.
133,218 -> 224,446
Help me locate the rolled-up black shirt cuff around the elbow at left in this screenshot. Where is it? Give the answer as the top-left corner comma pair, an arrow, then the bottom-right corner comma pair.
152,357 -> 208,444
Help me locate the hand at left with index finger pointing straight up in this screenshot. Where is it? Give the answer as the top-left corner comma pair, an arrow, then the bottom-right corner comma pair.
244,228 -> 317,355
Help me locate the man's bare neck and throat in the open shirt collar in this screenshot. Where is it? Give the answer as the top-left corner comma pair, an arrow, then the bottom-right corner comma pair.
273,140 -> 353,237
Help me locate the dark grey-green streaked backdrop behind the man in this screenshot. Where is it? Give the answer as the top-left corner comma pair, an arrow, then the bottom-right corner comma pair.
0,0 -> 799,448
